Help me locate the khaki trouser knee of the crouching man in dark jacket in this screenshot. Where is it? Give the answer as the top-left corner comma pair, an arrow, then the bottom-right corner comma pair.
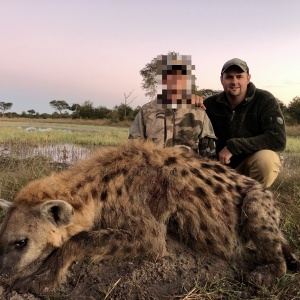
235,150 -> 281,187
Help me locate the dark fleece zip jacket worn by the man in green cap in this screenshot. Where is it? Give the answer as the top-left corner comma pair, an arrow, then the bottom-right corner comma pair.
204,82 -> 286,168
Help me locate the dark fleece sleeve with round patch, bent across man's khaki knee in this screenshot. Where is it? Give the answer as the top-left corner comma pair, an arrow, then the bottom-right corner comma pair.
226,94 -> 286,155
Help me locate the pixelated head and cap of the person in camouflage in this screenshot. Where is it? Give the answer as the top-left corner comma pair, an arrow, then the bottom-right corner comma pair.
157,55 -> 195,109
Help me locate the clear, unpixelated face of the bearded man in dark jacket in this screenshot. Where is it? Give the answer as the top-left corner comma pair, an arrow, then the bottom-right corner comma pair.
220,66 -> 251,98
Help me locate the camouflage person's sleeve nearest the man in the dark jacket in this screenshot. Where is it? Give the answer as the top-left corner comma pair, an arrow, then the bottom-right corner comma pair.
199,115 -> 217,159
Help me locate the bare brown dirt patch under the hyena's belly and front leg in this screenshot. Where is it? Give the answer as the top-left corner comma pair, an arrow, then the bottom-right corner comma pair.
0,237 -> 235,300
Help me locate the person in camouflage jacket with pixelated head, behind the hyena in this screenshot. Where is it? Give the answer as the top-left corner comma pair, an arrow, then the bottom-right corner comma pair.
129,55 -> 216,157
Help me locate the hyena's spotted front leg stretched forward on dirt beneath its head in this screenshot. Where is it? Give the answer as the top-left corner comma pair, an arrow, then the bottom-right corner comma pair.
12,223 -> 166,293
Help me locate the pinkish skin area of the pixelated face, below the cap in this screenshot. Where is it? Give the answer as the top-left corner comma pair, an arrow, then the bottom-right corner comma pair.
163,70 -> 187,103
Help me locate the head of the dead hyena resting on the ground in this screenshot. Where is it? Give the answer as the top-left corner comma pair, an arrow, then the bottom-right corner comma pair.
0,200 -> 74,278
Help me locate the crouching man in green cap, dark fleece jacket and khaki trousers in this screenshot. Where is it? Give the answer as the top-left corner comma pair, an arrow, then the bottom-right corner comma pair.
196,58 -> 286,187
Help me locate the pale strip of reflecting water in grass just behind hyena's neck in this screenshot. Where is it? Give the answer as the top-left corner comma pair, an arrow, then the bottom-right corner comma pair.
0,144 -> 100,164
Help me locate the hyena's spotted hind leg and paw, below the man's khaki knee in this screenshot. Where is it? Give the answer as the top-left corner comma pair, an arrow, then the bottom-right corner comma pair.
241,184 -> 286,285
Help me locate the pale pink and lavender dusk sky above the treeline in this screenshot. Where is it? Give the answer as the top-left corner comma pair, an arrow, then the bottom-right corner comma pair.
0,0 -> 300,113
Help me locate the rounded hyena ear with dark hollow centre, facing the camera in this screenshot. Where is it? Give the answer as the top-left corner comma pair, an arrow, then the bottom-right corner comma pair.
41,200 -> 74,227
